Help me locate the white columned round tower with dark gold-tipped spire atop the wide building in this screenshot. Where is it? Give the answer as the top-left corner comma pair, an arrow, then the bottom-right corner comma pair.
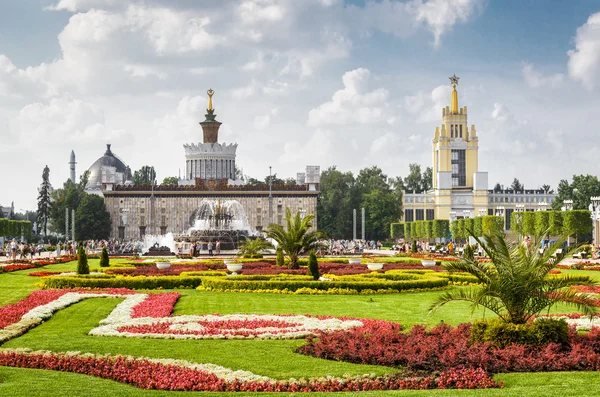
180,88 -> 237,185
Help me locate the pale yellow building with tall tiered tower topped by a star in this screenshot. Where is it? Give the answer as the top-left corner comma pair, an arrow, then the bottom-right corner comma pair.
403,75 -> 556,229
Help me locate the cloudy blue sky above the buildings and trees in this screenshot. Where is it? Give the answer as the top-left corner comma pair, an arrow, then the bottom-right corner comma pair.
0,0 -> 600,211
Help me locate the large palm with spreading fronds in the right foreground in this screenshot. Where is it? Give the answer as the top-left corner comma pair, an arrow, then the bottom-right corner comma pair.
430,231 -> 597,324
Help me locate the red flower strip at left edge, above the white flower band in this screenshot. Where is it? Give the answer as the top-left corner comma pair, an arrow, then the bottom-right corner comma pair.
0,288 -> 136,328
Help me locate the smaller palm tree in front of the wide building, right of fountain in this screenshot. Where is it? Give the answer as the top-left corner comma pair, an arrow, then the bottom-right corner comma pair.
267,208 -> 321,269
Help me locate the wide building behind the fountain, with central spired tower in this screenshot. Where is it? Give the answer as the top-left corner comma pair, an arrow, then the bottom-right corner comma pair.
102,90 -> 320,240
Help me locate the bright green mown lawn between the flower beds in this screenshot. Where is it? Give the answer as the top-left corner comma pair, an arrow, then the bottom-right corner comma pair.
0,260 -> 600,396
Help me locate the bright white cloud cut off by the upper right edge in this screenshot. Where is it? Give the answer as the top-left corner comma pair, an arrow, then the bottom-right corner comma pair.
568,12 -> 600,89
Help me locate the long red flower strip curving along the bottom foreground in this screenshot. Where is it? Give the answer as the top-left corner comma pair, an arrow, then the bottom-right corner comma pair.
0,352 -> 498,392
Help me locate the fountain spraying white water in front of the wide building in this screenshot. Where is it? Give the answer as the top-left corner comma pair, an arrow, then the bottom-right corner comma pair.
175,199 -> 255,251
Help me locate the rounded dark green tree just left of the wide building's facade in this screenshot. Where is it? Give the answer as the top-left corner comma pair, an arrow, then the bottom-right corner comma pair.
75,193 -> 111,240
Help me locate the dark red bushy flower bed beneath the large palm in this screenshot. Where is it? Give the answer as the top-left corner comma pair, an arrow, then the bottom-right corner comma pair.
299,320 -> 600,373
